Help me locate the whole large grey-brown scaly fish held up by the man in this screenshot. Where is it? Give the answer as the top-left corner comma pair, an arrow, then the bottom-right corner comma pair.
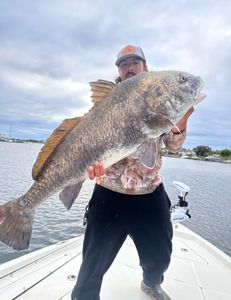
0,71 -> 205,250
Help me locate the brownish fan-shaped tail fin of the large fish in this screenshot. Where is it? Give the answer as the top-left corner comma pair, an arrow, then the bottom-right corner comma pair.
0,196 -> 34,250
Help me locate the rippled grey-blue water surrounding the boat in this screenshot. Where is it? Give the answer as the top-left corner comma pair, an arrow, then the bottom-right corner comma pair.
0,143 -> 231,263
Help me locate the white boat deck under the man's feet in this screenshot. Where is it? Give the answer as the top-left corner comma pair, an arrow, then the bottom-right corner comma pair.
0,225 -> 231,300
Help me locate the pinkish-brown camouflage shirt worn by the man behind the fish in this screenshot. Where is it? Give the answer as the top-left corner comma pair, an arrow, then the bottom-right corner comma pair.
97,131 -> 185,195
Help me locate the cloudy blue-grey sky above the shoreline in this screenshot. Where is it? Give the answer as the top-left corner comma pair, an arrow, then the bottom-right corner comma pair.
0,0 -> 231,149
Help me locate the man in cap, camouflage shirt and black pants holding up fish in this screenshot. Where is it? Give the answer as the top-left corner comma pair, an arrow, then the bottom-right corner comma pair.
72,45 -> 194,300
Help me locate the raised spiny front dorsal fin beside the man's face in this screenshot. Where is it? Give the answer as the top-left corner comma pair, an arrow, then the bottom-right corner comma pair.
90,79 -> 116,104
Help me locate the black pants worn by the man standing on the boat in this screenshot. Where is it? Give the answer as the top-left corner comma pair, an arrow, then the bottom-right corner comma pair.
72,184 -> 172,300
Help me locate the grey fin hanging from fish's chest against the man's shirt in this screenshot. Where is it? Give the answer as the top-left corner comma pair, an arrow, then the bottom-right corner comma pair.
135,139 -> 158,169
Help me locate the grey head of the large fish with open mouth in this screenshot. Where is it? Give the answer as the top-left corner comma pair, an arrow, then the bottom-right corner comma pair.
147,71 -> 206,124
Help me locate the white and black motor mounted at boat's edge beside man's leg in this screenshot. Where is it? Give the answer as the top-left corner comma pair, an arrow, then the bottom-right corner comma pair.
171,181 -> 191,224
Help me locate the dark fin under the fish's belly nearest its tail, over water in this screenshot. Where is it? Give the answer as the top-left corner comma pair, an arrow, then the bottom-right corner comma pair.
59,181 -> 83,209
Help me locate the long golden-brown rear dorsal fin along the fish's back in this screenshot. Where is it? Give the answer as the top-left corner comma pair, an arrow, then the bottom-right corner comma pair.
32,117 -> 81,180
